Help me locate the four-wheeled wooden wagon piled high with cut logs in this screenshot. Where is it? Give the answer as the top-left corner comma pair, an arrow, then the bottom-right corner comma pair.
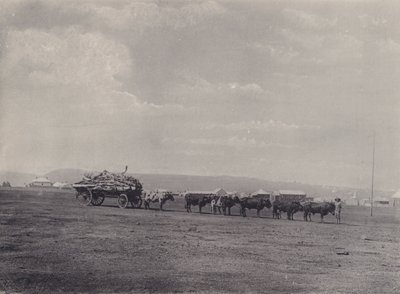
72,168 -> 143,208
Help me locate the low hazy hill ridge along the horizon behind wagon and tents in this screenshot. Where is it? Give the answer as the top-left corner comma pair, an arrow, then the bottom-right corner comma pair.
0,169 -> 391,199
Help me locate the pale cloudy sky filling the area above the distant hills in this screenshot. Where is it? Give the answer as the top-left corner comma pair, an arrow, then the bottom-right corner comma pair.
0,0 -> 400,189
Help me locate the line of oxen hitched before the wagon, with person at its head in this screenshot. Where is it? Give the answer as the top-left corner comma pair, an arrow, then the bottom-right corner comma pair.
144,191 -> 340,223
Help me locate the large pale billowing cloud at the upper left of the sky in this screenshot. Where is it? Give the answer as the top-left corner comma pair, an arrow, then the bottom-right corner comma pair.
3,27 -> 131,89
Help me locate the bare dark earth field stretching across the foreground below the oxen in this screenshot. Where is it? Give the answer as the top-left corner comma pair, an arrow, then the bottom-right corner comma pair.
0,189 -> 400,293
